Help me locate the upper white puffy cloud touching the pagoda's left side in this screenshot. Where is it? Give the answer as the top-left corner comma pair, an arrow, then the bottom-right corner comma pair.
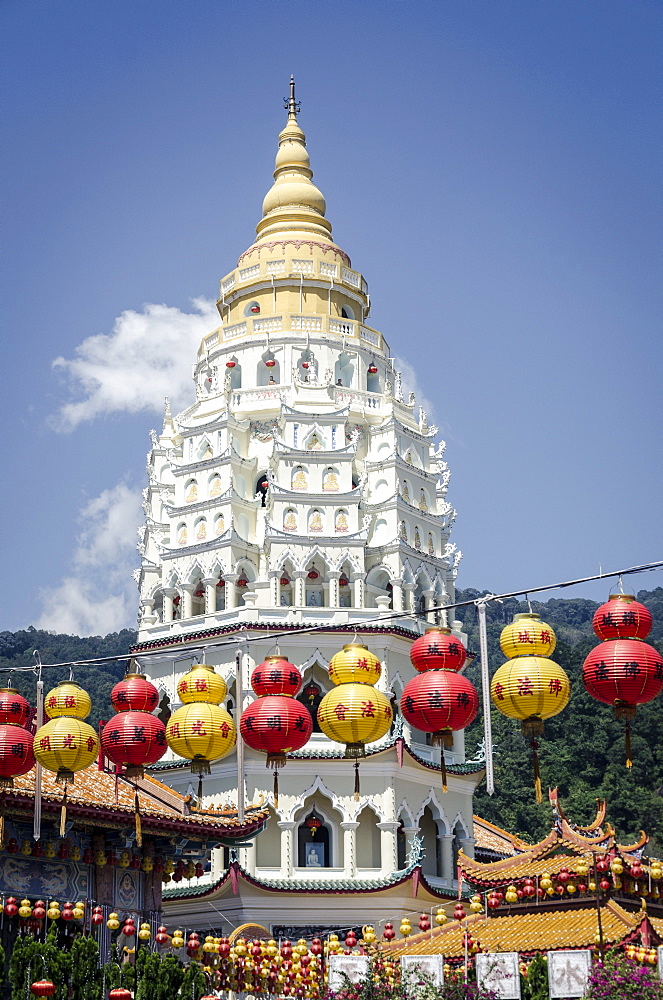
53,298 -> 219,431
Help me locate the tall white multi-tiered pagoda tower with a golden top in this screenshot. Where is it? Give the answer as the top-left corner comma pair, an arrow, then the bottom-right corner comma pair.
134,82 -> 483,936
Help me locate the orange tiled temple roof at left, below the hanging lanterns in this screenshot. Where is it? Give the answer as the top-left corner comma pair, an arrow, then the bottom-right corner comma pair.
2,766 -> 268,840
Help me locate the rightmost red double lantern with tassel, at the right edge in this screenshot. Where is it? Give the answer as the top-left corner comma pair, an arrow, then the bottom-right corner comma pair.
582,594 -> 663,768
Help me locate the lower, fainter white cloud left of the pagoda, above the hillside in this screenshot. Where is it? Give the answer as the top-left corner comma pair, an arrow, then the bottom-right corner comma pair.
35,483 -> 143,635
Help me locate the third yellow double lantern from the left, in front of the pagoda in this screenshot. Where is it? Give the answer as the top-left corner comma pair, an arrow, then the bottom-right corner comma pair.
318,643 -> 393,799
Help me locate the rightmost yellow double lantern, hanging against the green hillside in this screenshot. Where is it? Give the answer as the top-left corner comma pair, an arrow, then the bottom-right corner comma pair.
490,615 -> 571,802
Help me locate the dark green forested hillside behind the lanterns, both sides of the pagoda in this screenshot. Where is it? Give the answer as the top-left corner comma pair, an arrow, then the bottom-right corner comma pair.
0,587 -> 663,857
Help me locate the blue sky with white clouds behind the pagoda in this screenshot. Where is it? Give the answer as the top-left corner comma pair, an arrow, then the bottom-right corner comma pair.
0,0 -> 663,633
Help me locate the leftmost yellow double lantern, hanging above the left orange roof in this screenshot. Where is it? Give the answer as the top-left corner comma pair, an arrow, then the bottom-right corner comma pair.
34,681 -> 99,784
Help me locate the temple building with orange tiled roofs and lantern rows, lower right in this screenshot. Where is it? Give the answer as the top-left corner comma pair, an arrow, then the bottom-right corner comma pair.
385,789 -> 663,964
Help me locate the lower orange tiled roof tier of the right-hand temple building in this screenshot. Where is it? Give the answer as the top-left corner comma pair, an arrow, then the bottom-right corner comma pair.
387,900 -> 663,958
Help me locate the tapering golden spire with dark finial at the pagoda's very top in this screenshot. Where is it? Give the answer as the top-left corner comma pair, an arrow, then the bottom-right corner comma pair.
256,76 -> 332,241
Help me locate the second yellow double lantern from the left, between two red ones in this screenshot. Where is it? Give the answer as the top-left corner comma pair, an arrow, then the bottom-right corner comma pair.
166,663 -> 237,776
